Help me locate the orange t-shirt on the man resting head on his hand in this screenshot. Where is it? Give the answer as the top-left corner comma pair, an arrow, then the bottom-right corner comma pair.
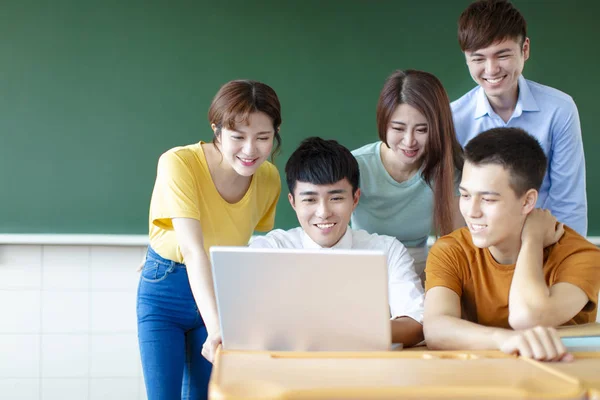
425,226 -> 600,328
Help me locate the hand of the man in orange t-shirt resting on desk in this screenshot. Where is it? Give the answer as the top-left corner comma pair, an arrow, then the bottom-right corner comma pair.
496,326 -> 573,361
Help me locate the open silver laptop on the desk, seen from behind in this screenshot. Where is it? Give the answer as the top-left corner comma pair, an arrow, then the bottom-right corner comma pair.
210,246 -> 391,351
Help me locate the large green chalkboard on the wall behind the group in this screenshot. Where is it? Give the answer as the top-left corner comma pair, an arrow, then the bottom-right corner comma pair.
0,0 -> 600,235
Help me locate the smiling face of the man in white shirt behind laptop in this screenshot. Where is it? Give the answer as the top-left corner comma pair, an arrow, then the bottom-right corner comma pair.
288,178 -> 360,247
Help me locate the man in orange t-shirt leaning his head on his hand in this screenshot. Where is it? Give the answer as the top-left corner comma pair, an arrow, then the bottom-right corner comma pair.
423,128 -> 600,360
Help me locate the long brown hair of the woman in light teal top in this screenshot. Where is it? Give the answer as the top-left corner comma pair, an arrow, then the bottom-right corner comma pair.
377,69 -> 464,235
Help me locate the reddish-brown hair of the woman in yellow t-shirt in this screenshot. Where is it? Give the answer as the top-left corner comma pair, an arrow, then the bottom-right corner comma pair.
208,79 -> 281,159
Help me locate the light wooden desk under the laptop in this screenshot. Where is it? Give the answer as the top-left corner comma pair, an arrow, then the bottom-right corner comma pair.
209,324 -> 600,400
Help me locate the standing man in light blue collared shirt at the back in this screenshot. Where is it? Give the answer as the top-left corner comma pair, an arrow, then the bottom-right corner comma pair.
451,0 -> 587,236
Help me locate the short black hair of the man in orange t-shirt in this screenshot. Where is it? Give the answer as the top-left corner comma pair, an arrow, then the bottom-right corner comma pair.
465,128 -> 548,196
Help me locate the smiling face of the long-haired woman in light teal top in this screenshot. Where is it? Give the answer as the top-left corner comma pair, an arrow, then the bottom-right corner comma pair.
386,103 -> 429,168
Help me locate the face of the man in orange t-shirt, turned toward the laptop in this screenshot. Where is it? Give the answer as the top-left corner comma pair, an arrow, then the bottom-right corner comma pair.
460,161 -> 537,262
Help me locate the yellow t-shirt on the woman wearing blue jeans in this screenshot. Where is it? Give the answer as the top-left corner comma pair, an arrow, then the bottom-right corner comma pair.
150,142 -> 281,263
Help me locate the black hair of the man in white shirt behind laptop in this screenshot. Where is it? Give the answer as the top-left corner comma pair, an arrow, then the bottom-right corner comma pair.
285,137 -> 360,196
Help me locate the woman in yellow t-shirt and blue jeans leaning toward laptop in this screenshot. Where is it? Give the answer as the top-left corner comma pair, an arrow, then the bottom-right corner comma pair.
137,80 -> 281,400
